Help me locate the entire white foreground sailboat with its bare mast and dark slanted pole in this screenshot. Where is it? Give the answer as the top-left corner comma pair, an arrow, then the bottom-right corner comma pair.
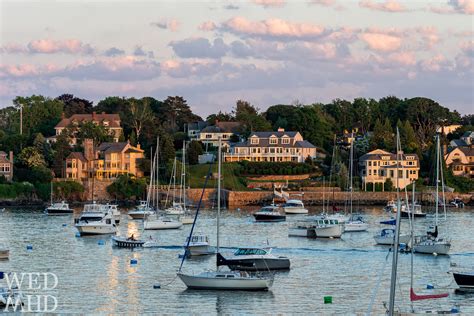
177,138 -> 273,291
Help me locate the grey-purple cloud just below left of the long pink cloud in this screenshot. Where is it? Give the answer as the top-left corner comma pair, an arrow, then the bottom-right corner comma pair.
169,37 -> 229,58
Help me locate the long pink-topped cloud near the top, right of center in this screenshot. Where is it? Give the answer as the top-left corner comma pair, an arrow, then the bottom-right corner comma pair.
223,17 -> 325,38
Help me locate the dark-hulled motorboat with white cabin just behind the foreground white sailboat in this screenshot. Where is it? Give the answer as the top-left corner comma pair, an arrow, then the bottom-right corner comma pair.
217,248 -> 290,271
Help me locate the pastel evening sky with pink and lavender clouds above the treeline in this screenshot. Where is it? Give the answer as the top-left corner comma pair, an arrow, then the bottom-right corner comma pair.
0,0 -> 474,117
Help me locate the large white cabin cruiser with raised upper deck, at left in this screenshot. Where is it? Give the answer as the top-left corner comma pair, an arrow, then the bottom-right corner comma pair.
74,203 -> 117,235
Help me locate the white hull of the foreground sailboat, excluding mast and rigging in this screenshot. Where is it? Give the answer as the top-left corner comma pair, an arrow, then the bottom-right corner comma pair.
178,272 -> 271,291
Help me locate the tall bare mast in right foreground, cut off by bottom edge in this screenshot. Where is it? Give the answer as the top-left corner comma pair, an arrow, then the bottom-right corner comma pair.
388,127 -> 403,316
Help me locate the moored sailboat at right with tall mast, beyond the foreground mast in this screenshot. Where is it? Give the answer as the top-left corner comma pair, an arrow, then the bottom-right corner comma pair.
413,134 -> 451,255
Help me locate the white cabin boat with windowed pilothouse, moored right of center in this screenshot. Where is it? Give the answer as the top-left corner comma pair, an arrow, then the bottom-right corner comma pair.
288,217 -> 345,238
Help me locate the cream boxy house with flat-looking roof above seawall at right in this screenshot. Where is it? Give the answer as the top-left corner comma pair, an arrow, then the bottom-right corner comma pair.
359,149 -> 420,191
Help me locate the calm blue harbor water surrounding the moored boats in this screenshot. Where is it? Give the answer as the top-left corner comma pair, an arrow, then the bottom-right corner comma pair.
0,208 -> 474,314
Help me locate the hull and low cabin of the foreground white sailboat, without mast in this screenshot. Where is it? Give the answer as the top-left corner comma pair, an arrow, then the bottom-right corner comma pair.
178,271 -> 273,291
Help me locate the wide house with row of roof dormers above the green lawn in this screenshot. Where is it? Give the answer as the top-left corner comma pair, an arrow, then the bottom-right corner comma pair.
224,128 -> 317,162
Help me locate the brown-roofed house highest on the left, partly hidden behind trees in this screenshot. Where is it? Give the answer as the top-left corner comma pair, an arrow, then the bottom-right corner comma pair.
48,112 -> 122,145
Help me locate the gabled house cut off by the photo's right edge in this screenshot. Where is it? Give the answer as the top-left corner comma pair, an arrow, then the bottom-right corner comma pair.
444,145 -> 474,178
